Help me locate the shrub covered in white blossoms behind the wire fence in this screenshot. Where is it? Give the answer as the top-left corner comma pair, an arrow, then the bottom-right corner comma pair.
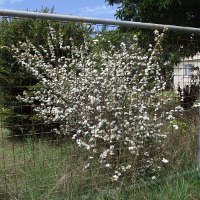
9,24 -> 180,181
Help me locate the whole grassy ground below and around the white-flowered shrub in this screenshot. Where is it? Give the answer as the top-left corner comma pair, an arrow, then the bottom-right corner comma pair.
0,106 -> 200,200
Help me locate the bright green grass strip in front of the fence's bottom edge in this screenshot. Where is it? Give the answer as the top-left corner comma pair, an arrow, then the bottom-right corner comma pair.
92,170 -> 200,200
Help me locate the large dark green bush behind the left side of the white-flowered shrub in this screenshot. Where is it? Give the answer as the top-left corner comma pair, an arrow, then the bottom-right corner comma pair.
0,8 -> 90,135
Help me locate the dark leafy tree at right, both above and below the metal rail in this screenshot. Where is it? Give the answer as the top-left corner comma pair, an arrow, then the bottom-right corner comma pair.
105,0 -> 200,88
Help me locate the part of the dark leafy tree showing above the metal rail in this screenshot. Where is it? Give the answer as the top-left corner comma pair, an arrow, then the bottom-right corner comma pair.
106,0 -> 200,28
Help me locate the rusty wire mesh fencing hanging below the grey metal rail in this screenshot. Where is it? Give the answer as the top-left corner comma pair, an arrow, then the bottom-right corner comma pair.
0,11 -> 200,199
